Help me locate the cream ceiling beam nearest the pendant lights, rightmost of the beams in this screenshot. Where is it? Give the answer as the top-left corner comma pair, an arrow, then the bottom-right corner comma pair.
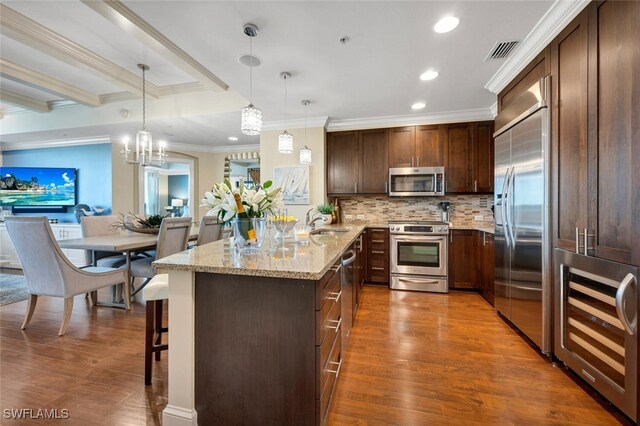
81,0 -> 229,91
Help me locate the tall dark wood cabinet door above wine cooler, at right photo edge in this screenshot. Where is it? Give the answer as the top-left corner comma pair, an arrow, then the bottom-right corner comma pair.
588,1 -> 640,265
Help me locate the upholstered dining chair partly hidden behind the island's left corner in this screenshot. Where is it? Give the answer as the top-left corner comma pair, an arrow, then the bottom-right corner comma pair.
131,217 -> 191,295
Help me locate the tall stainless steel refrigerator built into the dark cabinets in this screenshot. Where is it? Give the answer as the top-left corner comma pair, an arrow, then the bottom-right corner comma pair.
494,79 -> 551,353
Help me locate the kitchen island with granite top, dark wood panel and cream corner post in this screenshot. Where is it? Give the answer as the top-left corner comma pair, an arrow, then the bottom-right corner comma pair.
155,225 -> 365,425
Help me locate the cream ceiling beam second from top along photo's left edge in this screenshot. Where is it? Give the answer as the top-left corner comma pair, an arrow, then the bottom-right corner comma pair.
0,58 -> 100,107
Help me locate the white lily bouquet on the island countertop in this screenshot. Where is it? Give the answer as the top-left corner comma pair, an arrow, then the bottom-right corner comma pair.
200,179 -> 284,224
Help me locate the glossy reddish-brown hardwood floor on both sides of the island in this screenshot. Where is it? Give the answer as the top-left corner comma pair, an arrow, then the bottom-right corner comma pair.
0,287 -> 620,425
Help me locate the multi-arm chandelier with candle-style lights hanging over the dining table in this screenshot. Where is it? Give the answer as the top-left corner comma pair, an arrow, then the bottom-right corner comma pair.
120,64 -> 167,166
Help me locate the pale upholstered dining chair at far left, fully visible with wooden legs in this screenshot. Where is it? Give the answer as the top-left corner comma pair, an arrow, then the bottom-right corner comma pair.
5,216 -> 130,336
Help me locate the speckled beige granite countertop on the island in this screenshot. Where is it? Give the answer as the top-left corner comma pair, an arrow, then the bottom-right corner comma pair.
154,224 -> 364,280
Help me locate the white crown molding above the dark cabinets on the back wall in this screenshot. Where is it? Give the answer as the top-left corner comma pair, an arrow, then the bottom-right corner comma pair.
327,108 -> 494,131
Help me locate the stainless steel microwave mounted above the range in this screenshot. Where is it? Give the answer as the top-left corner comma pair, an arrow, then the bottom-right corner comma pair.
389,167 -> 444,197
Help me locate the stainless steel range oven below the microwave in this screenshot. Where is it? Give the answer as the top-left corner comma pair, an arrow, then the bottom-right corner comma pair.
389,222 -> 449,293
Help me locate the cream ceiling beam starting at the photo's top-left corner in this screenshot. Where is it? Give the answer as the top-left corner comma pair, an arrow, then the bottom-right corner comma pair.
0,4 -> 159,98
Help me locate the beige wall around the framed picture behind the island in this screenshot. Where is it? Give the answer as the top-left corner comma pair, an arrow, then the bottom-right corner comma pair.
260,127 -> 326,219
